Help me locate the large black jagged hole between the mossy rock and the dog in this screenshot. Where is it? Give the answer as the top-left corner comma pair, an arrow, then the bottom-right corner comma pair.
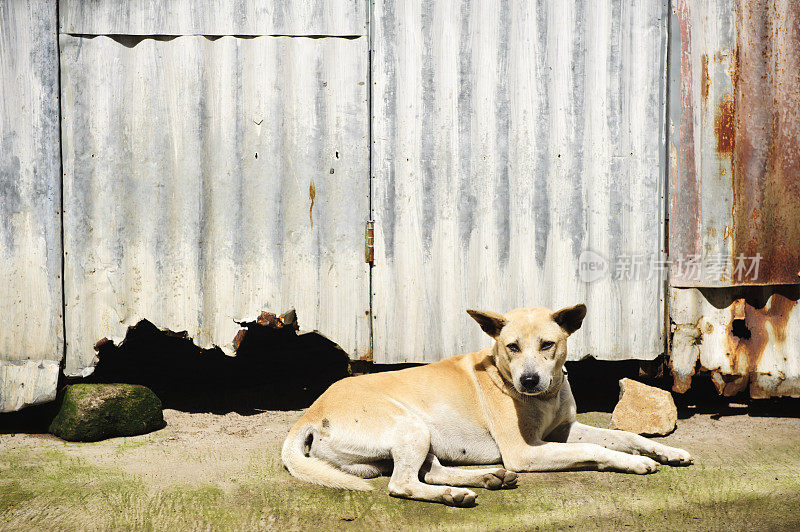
80,321 -> 349,415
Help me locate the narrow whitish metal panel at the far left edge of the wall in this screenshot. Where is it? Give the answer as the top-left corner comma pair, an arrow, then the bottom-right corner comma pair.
0,0 -> 64,412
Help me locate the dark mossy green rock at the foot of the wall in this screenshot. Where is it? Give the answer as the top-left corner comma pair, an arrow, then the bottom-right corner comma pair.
50,384 -> 165,441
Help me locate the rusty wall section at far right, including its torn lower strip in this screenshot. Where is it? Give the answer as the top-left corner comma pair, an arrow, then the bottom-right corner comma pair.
669,0 -> 800,398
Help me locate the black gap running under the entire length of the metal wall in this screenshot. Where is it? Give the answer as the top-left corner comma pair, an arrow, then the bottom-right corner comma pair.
0,344 -> 800,433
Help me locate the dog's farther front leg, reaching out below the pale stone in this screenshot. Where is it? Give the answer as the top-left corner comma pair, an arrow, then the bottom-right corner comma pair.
554,422 -> 694,465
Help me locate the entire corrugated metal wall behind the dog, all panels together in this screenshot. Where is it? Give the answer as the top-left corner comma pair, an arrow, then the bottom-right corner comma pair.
0,0 -> 800,411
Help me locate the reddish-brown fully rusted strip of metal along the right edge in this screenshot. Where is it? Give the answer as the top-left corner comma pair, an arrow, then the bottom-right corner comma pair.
732,0 -> 800,284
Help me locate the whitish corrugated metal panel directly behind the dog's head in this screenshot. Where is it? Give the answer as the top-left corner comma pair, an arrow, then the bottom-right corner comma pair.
372,0 -> 668,362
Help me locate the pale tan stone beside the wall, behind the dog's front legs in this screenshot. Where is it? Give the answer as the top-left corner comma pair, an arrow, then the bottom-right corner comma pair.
611,379 -> 678,435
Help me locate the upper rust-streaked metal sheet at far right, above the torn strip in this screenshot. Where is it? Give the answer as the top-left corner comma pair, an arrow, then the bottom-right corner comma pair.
669,0 -> 800,287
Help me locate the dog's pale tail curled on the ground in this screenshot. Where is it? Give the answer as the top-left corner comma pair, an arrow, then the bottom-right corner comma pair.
281,425 -> 374,491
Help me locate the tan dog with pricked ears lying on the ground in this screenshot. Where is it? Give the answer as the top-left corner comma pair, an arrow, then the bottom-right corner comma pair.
283,305 -> 692,506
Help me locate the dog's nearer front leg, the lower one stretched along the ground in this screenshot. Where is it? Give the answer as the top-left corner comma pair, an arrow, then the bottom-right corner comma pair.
503,442 -> 658,475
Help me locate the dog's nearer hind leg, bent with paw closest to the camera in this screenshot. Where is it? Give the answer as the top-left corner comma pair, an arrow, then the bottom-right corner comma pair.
389,414 -> 477,506
